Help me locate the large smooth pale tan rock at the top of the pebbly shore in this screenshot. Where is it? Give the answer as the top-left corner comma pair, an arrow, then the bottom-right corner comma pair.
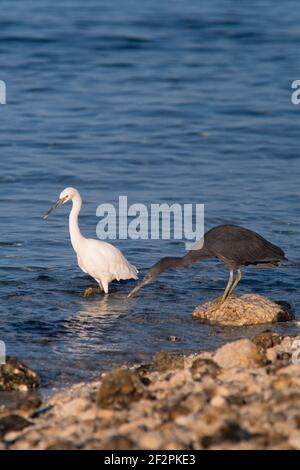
214,339 -> 265,369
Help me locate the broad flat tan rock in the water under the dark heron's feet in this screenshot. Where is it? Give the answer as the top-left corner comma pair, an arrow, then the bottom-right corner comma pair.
192,294 -> 294,326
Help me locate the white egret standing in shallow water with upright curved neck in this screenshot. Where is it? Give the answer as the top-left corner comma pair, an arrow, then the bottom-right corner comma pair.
44,188 -> 138,297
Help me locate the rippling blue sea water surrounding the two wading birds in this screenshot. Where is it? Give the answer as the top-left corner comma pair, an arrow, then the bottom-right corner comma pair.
0,0 -> 300,387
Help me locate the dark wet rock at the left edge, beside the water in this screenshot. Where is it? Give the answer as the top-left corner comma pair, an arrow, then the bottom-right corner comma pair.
0,357 -> 40,392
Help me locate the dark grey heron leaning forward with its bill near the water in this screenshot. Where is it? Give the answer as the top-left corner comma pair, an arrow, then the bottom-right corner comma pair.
128,224 -> 287,303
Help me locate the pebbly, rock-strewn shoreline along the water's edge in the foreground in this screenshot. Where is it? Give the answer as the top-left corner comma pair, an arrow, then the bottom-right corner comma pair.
0,331 -> 300,450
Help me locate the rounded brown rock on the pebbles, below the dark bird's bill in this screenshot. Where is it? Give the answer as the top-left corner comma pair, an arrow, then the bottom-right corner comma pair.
96,369 -> 146,408
